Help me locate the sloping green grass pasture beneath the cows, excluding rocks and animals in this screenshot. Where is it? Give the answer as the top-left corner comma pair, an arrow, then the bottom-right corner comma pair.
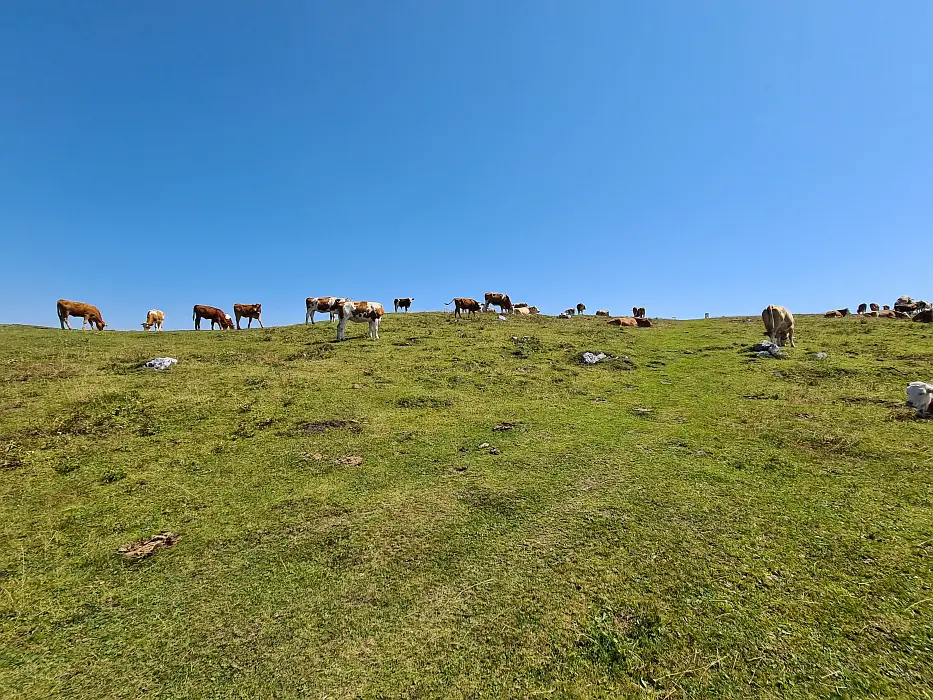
0,313 -> 933,698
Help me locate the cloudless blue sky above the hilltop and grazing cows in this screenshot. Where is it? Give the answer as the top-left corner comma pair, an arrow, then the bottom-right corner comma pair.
0,0 -> 933,329
